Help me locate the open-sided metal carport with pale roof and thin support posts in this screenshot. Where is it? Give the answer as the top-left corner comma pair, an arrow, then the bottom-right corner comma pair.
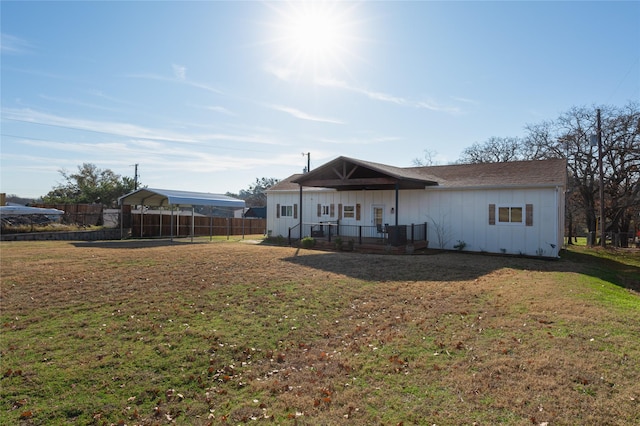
118,188 -> 245,241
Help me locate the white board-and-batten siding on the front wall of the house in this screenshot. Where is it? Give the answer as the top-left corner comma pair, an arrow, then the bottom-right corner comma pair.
267,187 -> 564,257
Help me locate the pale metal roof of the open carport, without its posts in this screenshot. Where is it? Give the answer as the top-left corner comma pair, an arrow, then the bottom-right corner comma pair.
118,188 -> 244,208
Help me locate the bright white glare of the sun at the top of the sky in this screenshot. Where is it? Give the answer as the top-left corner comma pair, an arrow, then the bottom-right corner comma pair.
274,1 -> 357,76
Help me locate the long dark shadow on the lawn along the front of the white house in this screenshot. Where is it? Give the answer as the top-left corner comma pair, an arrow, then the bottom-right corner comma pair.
284,251 -> 640,291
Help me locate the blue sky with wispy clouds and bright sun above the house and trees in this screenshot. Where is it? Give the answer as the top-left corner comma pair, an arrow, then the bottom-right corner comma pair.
0,1 -> 640,197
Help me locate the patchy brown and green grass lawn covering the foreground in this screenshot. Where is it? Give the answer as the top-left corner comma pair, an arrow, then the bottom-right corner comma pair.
0,238 -> 640,425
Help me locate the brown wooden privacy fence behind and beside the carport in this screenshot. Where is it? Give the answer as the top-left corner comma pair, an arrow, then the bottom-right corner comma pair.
131,212 -> 267,238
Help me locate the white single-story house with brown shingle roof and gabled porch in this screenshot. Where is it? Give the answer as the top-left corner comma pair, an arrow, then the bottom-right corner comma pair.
267,157 -> 567,257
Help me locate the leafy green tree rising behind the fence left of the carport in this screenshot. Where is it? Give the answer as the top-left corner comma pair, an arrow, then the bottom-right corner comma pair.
42,163 -> 135,207
